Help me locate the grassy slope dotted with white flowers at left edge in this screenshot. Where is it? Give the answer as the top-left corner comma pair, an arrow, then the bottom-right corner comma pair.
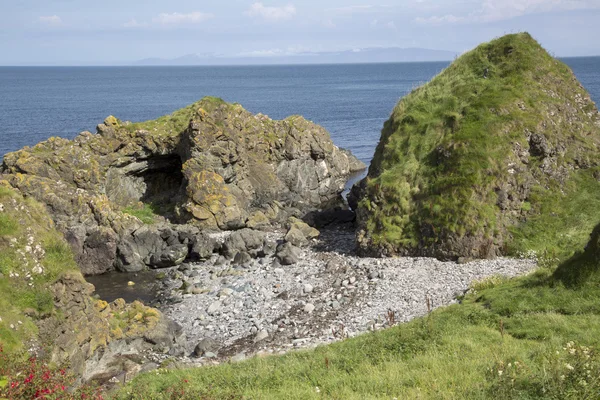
0,181 -> 78,352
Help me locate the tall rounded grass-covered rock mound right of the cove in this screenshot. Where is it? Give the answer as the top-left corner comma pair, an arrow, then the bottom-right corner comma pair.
354,33 -> 600,259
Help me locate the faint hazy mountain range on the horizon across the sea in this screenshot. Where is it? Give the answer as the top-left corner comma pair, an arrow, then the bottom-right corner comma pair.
134,47 -> 459,65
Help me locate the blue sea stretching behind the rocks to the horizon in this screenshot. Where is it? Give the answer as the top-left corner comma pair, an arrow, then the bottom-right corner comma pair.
0,57 -> 600,164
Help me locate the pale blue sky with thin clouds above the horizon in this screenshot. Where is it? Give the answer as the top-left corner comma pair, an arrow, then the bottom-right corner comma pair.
0,0 -> 600,65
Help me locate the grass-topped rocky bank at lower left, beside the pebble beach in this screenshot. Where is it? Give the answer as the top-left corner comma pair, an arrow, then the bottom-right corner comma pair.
0,179 -> 183,380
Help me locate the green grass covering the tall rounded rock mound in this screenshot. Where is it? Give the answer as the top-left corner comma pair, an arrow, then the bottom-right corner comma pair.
360,33 -> 600,254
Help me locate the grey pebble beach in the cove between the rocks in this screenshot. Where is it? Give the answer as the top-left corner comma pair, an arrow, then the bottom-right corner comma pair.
134,224 -> 537,367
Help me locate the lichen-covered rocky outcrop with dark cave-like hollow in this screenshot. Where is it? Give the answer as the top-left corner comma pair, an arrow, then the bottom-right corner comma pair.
2,98 -> 364,274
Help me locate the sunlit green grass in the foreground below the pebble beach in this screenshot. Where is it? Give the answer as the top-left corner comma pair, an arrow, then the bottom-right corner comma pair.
115,228 -> 600,399
